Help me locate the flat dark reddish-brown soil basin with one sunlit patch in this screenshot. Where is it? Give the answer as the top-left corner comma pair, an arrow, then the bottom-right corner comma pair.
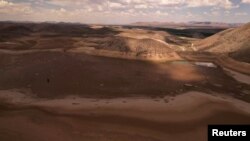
0,52 -> 249,98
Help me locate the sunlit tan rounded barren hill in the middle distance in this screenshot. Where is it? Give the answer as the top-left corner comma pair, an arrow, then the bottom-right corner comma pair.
82,30 -> 173,55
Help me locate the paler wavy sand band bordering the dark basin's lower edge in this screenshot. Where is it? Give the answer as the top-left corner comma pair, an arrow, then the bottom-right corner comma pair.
0,91 -> 250,121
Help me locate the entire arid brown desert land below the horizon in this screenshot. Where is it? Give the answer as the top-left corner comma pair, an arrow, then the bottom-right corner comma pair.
0,22 -> 250,141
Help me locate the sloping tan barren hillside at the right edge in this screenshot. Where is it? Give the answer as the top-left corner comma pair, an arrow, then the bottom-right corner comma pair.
194,23 -> 250,62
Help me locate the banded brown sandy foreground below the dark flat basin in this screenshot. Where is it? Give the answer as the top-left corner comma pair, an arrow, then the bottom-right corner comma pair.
0,90 -> 250,141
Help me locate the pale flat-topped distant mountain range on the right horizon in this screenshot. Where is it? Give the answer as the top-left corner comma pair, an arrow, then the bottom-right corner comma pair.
131,21 -> 243,28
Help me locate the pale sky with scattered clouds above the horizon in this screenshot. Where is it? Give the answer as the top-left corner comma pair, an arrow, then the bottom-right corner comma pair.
0,0 -> 250,24
